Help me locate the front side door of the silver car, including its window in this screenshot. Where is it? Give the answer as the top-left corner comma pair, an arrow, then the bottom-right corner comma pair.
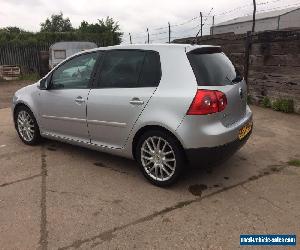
39,52 -> 98,141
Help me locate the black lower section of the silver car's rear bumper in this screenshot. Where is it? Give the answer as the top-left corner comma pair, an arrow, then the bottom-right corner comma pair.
185,128 -> 253,167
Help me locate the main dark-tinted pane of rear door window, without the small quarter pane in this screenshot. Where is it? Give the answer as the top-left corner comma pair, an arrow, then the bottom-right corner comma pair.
99,50 -> 146,88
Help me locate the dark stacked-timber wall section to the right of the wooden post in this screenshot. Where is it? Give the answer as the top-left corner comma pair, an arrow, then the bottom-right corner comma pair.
248,31 -> 300,114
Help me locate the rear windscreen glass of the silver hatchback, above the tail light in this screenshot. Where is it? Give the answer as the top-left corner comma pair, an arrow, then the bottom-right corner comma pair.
187,50 -> 243,86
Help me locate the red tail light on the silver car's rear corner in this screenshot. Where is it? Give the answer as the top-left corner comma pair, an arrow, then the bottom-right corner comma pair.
187,89 -> 227,115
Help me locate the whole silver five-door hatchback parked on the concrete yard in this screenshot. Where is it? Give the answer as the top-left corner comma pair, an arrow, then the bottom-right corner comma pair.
12,44 -> 252,186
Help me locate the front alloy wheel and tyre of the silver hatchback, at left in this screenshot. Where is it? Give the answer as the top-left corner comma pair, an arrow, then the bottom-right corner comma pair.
15,106 -> 41,145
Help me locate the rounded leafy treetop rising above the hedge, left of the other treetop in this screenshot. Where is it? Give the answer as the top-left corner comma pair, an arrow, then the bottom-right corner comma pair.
41,12 -> 73,32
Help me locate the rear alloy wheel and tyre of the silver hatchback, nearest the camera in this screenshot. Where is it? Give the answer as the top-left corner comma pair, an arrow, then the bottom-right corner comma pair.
136,130 -> 185,187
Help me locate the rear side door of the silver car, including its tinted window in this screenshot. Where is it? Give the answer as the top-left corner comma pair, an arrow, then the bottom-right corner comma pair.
87,50 -> 161,148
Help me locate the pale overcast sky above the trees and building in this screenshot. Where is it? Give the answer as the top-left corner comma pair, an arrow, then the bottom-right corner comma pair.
0,0 -> 300,43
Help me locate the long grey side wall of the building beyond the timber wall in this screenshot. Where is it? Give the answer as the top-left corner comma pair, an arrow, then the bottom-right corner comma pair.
213,17 -> 278,34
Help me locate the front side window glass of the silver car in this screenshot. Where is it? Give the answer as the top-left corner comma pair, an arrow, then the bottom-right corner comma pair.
51,52 -> 98,89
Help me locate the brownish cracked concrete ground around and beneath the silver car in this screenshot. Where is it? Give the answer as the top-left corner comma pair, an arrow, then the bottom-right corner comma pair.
0,104 -> 300,249
